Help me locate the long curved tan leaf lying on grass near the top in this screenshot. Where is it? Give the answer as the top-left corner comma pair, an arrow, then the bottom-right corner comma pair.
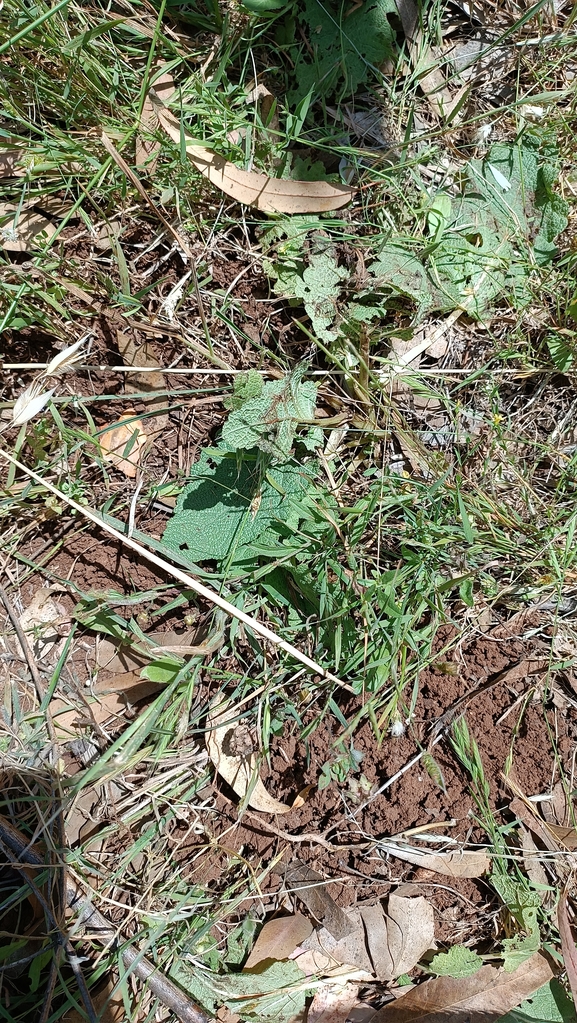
150,97 -> 354,213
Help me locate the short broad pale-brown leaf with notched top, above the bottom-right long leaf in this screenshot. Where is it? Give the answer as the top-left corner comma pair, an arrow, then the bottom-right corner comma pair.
361,895 -> 435,982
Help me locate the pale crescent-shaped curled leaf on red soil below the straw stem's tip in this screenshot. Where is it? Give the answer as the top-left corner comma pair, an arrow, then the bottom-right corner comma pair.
207,703 -> 291,813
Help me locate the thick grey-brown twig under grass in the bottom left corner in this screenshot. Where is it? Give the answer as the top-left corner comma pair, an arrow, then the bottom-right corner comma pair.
0,816 -> 209,1023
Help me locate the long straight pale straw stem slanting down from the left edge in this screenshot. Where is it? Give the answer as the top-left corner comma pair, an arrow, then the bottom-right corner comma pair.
0,449 -> 354,693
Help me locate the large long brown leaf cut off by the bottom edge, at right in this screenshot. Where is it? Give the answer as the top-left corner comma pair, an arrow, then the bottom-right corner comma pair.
371,952 -> 553,1023
